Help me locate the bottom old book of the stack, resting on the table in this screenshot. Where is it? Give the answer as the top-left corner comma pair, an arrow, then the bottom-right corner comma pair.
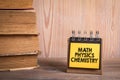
0,52 -> 38,71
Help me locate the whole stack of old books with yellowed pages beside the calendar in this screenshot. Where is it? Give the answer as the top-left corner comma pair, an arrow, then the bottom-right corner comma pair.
0,0 -> 40,71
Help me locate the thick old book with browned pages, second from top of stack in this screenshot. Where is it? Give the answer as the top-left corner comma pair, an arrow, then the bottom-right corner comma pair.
0,10 -> 38,35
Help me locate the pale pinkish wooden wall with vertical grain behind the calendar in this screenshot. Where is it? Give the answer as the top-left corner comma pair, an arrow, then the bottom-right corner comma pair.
33,0 -> 120,58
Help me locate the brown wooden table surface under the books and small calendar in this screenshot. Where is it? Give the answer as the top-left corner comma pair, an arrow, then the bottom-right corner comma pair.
0,58 -> 120,80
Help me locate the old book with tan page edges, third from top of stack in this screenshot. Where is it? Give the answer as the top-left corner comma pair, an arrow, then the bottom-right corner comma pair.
0,35 -> 40,55
